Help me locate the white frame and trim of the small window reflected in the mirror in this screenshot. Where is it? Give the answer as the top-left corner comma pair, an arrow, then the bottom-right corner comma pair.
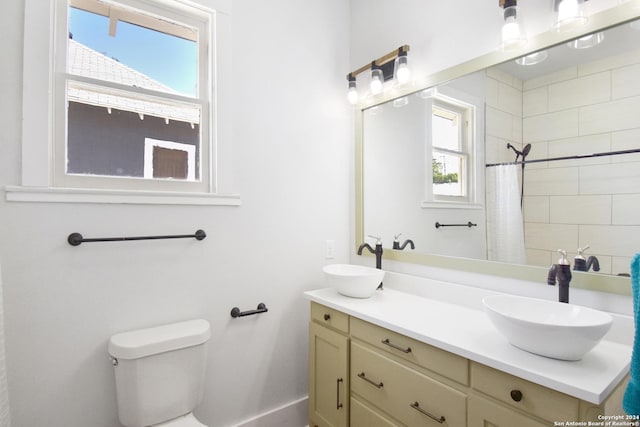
421,87 -> 484,209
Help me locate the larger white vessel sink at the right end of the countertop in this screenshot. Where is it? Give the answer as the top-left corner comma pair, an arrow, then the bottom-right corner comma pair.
482,295 -> 613,360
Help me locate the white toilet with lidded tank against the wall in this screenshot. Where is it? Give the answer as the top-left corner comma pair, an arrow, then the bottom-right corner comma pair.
108,319 -> 211,427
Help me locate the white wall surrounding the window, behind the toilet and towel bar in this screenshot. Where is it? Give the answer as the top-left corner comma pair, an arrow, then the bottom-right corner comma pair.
0,0 -> 353,427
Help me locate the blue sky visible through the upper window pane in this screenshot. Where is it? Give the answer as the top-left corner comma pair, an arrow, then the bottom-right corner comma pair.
69,8 -> 197,96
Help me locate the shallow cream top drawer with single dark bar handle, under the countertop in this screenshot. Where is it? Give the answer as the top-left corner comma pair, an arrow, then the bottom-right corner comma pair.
351,318 -> 469,385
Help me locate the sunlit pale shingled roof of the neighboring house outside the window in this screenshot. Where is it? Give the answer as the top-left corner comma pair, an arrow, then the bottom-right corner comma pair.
67,39 -> 200,124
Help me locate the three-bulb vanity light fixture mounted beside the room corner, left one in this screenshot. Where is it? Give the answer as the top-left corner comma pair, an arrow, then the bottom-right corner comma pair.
347,45 -> 411,104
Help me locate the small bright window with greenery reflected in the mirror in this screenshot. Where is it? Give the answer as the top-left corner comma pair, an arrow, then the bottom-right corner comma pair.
427,89 -> 478,205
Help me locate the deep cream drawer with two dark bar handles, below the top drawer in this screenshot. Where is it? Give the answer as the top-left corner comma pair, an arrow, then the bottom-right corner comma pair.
351,341 -> 467,427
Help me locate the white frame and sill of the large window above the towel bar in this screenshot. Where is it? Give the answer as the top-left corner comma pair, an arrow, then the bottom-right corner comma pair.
6,0 -> 240,206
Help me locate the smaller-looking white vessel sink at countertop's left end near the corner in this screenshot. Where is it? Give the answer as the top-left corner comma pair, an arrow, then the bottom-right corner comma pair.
322,264 -> 384,298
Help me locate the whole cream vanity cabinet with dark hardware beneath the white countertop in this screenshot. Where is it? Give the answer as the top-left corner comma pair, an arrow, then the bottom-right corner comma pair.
309,302 -> 626,427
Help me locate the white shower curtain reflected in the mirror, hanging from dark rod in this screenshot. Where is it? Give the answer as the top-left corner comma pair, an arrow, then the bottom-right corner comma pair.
486,165 -> 527,264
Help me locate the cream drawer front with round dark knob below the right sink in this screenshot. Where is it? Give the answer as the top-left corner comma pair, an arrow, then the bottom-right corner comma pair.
471,363 -> 579,421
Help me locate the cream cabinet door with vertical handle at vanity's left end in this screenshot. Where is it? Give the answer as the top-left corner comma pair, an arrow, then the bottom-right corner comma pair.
309,322 -> 349,427
